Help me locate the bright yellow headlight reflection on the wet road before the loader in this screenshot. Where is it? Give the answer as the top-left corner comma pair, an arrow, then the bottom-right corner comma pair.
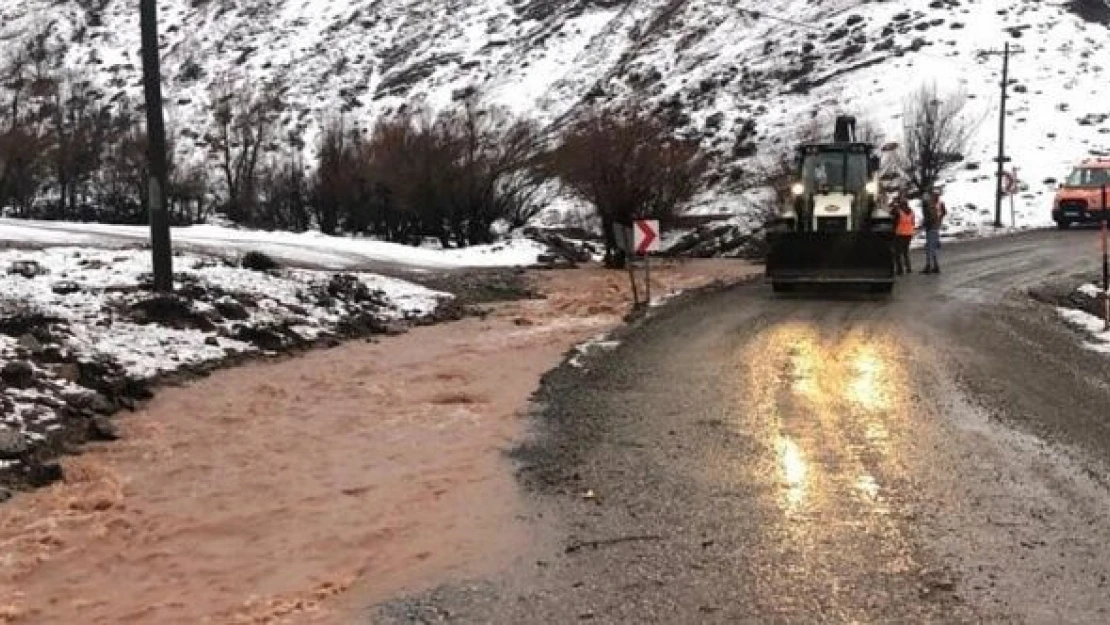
744,322 -> 910,517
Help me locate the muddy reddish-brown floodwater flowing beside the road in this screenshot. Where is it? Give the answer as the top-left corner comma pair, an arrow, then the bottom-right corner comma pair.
0,261 -> 753,624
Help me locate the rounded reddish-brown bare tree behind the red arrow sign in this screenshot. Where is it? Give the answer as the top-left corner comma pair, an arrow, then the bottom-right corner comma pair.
552,111 -> 707,266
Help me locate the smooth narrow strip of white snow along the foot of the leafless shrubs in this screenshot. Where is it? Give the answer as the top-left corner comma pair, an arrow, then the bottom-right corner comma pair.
0,219 -> 546,270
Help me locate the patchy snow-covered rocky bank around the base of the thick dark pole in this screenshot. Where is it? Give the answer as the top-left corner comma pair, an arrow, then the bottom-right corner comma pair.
0,248 -> 450,461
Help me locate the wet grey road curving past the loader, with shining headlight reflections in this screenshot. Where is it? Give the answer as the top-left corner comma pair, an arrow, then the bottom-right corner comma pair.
377,232 -> 1110,623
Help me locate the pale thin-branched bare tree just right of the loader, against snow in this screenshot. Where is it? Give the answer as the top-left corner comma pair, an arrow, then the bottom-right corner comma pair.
898,84 -> 973,193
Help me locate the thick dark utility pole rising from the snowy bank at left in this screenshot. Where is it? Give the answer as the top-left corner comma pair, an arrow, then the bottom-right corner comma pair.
139,0 -> 173,293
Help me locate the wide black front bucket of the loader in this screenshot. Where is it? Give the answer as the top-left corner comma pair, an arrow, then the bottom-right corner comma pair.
767,232 -> 894,289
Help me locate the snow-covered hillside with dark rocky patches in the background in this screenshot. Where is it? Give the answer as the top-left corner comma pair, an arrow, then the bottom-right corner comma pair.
0,0 -> 1110,229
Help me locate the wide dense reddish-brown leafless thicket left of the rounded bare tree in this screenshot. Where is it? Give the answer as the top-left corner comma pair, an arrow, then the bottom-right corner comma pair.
313,104 -> 544,246
